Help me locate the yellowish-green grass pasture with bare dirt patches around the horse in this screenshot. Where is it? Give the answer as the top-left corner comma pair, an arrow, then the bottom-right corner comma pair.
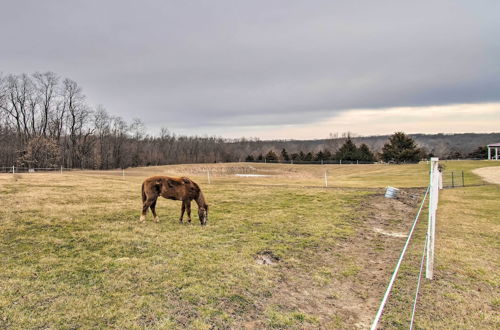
0,162 -> 500,329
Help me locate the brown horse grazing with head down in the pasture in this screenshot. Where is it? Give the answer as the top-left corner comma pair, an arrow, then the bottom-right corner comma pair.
139,176 -> 208,226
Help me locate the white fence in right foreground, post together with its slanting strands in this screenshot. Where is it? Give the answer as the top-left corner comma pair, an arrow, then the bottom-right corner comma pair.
370,158 -> 443,330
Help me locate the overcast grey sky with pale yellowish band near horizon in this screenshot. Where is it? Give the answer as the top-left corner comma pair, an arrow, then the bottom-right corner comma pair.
0,0 -> 500,139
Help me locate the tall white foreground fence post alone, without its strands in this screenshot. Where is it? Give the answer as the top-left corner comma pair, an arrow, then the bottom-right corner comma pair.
425,157 -> 440,280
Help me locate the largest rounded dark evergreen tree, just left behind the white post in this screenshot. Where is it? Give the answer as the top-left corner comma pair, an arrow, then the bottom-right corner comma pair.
381,132 -> 420,164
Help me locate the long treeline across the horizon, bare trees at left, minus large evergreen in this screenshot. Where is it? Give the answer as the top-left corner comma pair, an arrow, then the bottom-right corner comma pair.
0,72 -> 500,169
